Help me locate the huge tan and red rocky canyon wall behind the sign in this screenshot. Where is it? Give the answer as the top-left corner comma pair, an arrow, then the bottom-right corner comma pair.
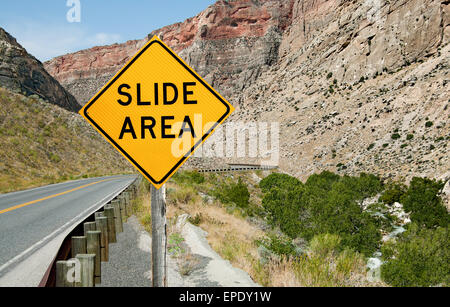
45,0 -> 450,182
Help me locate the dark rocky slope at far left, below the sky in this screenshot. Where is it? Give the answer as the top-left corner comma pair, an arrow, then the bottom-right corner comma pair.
0,28 -> 80,111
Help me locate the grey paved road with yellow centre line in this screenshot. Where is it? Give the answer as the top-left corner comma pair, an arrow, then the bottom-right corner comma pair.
0,176 -> 136,286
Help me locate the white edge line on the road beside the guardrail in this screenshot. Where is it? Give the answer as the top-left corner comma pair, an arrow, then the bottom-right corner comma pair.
0,178 -> 134,278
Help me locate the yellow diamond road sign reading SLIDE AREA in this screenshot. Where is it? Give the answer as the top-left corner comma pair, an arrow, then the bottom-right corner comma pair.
80,36 -> 234,188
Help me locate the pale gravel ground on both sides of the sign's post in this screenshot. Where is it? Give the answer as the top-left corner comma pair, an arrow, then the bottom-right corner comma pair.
97,216 -> 258,287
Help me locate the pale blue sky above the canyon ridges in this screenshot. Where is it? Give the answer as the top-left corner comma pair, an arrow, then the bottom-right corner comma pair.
0,0 -> 215,62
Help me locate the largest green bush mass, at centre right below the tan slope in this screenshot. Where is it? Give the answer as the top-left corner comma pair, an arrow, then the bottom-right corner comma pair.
262,171 -> 382,255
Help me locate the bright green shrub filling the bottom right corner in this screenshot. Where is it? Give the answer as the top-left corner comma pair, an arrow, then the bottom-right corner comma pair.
381,224 -> 450,287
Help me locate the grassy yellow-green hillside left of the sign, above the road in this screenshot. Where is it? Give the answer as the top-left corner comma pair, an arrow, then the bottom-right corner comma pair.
0,88 -> 132,193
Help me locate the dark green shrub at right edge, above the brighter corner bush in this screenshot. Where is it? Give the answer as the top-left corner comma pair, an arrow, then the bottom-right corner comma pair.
400,177 -> 450,228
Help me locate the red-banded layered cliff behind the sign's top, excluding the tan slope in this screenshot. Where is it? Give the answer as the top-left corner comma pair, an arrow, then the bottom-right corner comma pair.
45,0 -> 293,105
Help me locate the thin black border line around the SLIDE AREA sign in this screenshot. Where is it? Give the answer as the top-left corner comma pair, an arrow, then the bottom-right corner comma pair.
83,40 -> 231,185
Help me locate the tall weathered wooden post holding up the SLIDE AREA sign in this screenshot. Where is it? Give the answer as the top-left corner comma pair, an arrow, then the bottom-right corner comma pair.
150,185 -> 167,287
